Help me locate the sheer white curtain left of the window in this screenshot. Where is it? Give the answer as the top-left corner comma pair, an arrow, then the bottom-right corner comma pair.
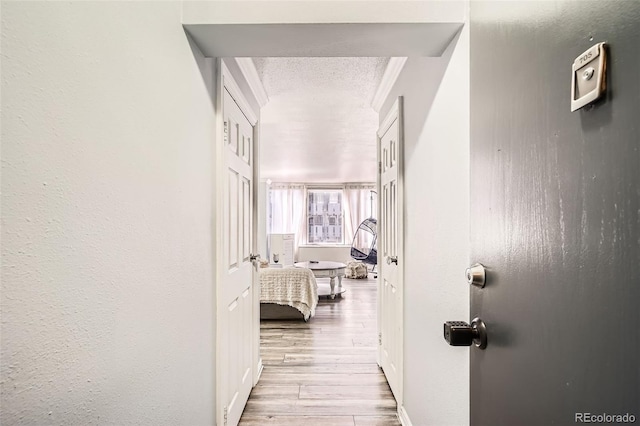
267,183 -> 305,257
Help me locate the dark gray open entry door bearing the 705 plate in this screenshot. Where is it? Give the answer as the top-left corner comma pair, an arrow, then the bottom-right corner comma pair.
470,1 -> 640,426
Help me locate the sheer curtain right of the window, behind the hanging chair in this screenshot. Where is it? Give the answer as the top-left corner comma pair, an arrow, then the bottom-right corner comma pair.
344,184 -> 378,245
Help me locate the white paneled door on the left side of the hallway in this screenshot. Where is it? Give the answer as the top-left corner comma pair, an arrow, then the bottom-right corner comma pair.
217,81 -> 255,425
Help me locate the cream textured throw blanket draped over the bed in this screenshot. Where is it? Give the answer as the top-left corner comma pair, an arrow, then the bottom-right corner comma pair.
260,268 -> 318,321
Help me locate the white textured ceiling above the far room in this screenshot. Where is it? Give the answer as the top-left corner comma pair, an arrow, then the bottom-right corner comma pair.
254,57 -> 389,182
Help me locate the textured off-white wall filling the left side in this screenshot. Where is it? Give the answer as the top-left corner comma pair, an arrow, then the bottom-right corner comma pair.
0,2 -> 215,425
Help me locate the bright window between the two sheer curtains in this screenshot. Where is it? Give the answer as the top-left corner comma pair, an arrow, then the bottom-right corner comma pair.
307,189 -> 344,244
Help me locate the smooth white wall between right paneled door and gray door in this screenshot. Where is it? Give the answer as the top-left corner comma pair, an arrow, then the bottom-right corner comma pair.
381,21 -> 470,426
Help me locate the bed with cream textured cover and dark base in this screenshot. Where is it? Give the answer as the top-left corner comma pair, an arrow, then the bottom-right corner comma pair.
260,267 -> 318,321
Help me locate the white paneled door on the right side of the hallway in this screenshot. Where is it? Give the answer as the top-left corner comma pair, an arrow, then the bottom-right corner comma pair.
378,98 -> 404,407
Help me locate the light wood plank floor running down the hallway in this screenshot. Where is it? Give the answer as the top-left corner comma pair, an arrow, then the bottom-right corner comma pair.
240,276 -> 400,426
